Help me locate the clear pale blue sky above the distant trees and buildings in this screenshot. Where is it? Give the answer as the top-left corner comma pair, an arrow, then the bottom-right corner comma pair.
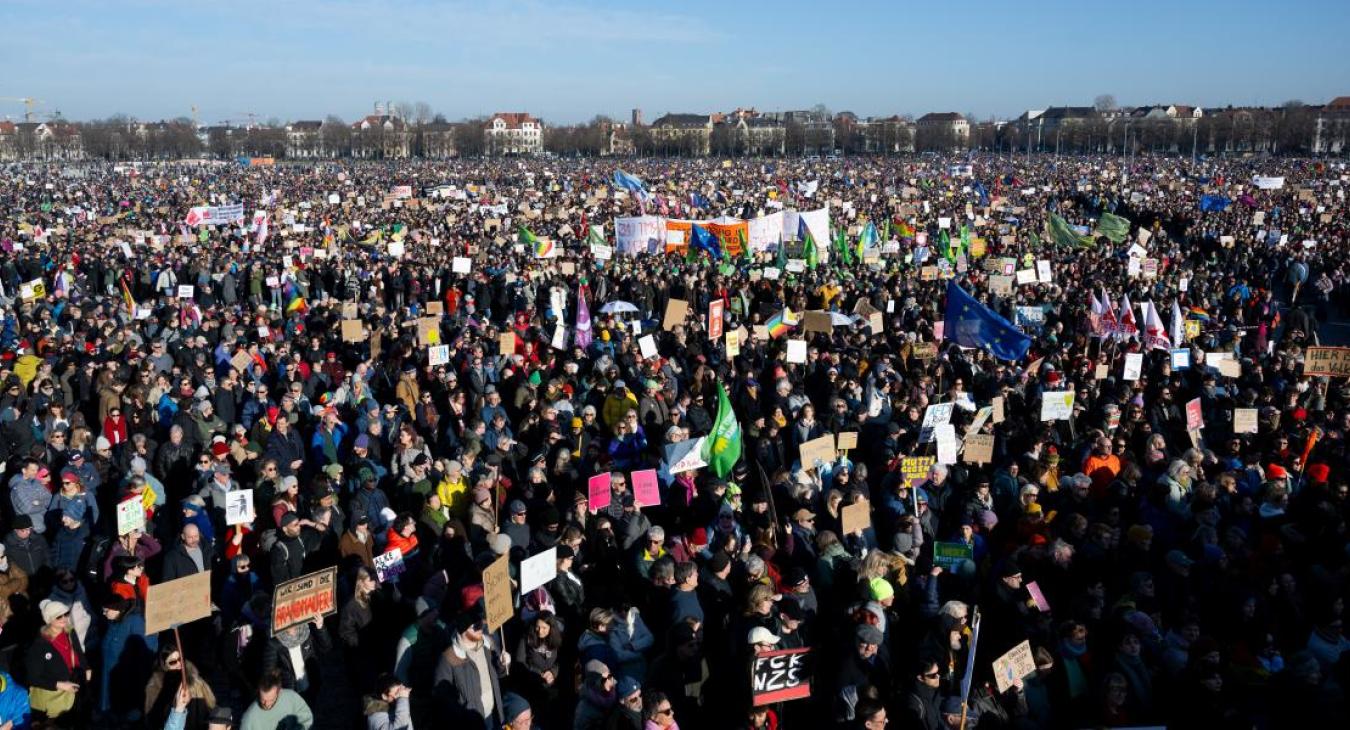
0,0 -> 1350,123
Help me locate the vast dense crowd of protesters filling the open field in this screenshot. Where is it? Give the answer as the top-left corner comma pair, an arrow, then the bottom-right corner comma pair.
0,151 -> 1350,730
